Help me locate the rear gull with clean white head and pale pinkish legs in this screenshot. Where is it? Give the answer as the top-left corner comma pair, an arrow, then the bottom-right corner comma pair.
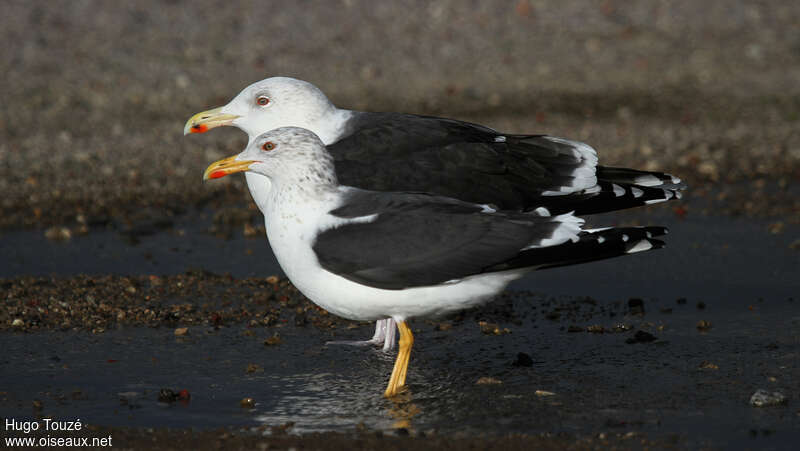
184,77 -> 685,350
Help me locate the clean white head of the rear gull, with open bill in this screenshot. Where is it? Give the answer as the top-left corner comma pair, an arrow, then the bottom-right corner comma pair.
183,77 -> 336,141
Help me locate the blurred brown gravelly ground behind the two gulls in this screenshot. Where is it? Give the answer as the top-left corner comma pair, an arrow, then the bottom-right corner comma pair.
0,0 -> 800,228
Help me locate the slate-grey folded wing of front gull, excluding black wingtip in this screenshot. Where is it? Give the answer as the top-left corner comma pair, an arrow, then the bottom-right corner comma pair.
313,190 -> 580,290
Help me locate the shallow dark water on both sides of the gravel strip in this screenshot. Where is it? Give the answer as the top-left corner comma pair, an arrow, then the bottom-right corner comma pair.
0,209 -> 800,448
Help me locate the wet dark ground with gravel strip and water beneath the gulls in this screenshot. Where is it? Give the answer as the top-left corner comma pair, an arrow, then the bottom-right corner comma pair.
0,207 -> 800,449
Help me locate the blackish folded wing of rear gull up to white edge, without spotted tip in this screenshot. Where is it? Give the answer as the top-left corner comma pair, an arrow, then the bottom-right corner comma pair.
328,113 -> 597,210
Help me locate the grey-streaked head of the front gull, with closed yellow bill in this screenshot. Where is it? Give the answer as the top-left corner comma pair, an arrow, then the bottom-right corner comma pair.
203,127 -> 335,182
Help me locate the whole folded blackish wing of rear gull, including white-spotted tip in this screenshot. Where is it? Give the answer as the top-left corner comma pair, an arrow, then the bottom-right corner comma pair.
328,113 -> 685,215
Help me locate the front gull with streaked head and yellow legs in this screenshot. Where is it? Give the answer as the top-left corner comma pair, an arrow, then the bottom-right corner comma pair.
203,127 -> 666,397
